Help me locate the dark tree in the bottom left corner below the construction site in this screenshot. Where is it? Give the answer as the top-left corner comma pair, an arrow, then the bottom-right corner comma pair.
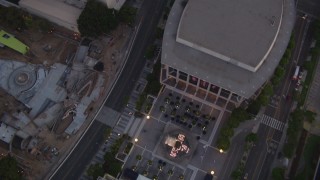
0,155 -> 22,180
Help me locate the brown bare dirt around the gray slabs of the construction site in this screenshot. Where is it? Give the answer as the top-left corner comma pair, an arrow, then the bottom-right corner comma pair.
0,25 -> 132,179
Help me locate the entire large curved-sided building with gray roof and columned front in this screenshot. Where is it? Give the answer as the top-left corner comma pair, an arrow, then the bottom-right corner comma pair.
161,0 -> 295,107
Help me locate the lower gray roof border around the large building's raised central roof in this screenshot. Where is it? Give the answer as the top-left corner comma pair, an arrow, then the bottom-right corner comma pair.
161,0 -> 295,98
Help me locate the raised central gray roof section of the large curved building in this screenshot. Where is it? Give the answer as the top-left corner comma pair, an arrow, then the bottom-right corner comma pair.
177,0 -> 282,71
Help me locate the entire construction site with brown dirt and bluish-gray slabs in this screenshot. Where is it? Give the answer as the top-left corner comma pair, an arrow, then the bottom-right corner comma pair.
0,21 -> 132,179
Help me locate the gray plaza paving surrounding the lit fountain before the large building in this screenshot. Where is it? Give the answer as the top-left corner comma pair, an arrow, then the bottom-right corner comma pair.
124,89 -> 228,179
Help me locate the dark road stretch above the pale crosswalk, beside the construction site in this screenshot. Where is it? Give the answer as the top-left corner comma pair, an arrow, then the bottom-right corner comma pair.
105,0 -> 167,112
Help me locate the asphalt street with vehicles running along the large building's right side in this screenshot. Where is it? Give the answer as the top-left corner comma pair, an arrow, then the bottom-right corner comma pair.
245,11 -> 311,179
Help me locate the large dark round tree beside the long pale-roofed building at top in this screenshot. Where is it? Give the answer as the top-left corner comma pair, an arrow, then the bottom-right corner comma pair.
77,0 -> 118,37
